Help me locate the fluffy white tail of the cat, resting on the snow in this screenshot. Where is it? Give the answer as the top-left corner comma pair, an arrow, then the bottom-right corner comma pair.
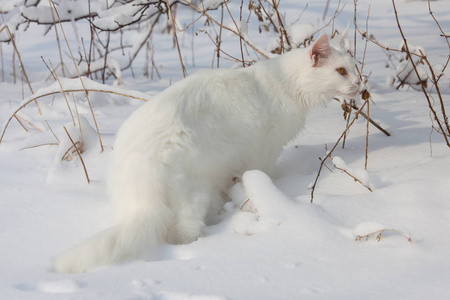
54,205 -> 169,273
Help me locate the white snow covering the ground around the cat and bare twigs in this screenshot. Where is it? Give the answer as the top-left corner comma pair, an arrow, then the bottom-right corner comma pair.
0,0 -> 450,300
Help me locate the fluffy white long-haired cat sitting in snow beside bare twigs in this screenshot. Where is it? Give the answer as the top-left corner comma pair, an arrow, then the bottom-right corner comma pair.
55,35 -> 360,273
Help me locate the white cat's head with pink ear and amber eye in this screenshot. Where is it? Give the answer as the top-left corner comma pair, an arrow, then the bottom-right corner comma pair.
304,35 -> 361,99
